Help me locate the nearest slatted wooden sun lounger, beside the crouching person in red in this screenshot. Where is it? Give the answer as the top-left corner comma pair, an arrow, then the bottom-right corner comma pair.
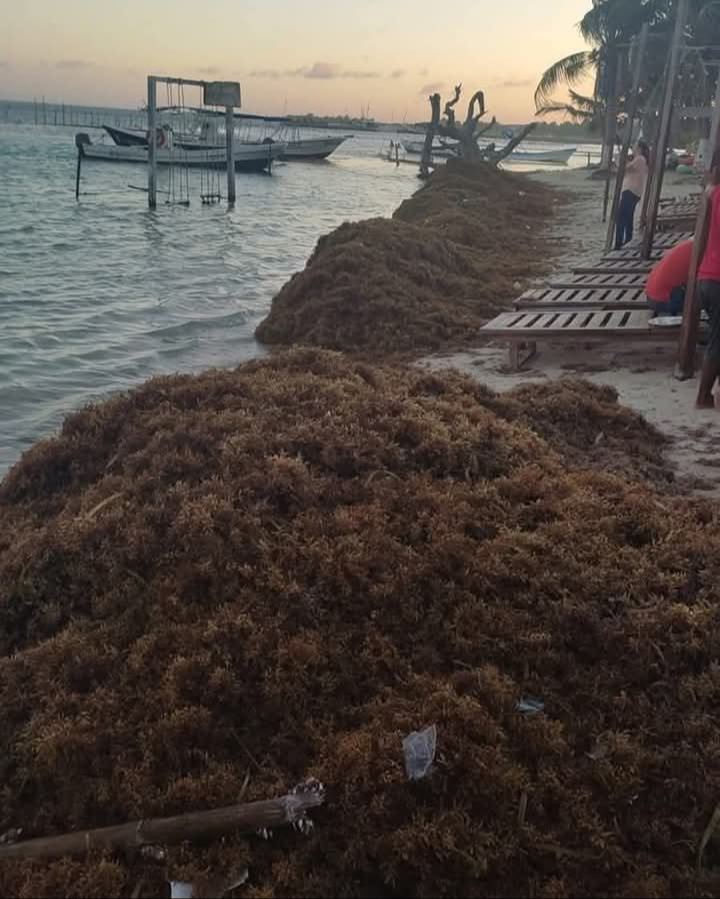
481,309 -> 680,371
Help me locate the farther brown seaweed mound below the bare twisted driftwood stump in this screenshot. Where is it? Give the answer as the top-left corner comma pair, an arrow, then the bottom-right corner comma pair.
256,162 -> 559,354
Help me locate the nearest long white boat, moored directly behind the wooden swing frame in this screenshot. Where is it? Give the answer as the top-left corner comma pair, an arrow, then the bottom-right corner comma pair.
76,134 -> 285,172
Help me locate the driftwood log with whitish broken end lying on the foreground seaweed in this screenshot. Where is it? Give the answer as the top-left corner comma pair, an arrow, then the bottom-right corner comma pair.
0,782 -> 325,862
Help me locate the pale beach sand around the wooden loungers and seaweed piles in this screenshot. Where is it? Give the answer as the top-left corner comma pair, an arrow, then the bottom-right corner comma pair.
422,170 -> 720,496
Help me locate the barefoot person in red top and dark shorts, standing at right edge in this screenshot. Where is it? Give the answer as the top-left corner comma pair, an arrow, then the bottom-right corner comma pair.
697,150 -> 720,409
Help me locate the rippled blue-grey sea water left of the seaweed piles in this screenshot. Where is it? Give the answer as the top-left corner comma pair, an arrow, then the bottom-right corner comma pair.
0,103 -> 592,476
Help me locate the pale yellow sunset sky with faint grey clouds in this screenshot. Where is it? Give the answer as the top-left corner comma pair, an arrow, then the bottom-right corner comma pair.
0,0 -> 590,122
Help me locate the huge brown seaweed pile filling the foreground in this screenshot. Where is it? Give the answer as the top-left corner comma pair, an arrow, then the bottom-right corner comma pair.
0,351 -> 720,897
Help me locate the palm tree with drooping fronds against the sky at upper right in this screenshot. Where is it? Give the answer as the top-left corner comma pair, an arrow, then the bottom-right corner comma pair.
535,0 -> 668,166
